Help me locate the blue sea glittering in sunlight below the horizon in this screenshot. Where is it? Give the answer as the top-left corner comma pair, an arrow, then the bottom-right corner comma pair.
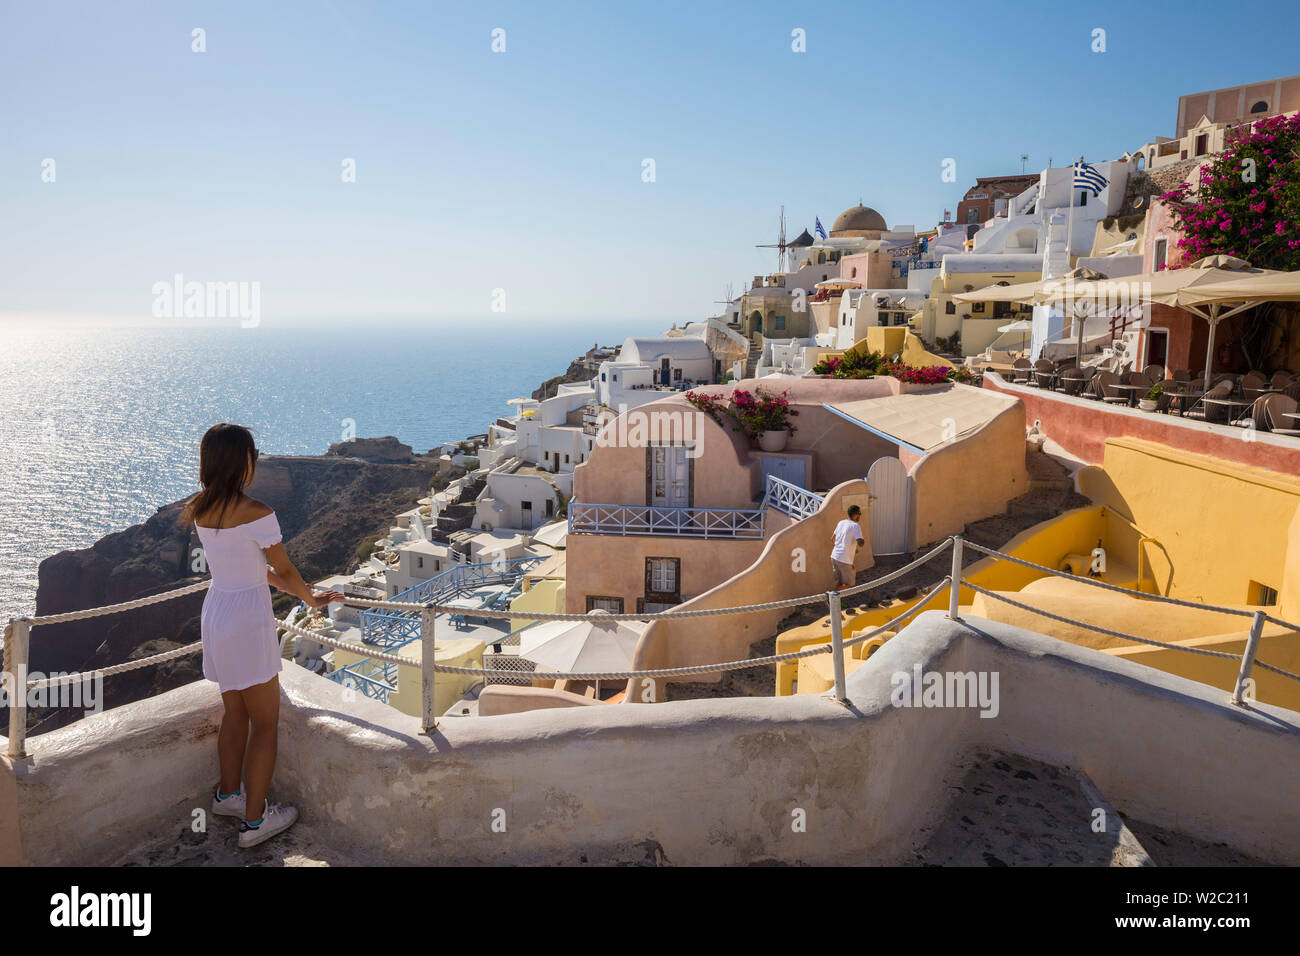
0,320 -> 670,620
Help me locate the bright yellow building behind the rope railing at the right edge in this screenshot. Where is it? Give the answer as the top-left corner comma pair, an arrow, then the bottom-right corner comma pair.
776,437 -> 1300,710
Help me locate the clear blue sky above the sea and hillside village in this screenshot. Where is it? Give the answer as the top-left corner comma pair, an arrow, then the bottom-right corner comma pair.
0,0 -> 1300,321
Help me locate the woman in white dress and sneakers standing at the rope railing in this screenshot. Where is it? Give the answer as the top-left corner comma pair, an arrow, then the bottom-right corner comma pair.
181,424 -> 343,847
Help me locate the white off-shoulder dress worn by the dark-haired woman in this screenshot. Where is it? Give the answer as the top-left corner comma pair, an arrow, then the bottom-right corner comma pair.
194,511 -> 281,693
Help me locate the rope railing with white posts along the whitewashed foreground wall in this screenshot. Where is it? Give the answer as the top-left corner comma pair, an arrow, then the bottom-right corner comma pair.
3,535 -> 1300,757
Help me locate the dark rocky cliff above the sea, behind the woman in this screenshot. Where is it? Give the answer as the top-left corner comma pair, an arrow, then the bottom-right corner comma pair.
31,438 -> 447,730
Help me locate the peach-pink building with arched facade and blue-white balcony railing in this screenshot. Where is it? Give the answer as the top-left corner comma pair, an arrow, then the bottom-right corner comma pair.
566,377 -> 1027,613
